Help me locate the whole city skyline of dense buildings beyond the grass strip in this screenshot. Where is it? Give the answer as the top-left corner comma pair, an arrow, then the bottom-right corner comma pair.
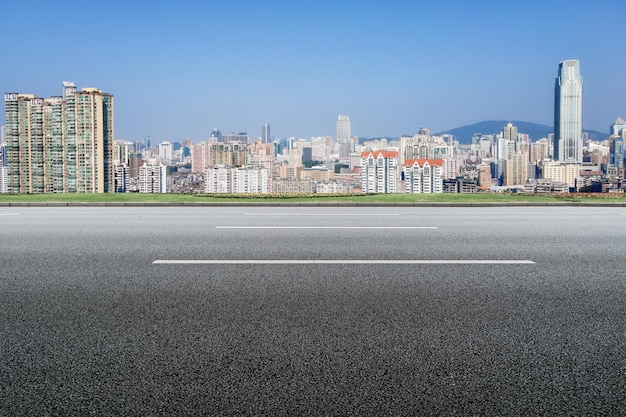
0,80 -> 626,194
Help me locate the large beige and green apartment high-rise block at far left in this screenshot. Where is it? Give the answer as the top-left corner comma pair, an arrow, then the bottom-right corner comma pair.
4,82 -> 114,193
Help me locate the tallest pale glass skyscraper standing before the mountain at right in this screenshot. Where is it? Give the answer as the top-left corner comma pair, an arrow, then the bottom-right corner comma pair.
553,59 -> 583,163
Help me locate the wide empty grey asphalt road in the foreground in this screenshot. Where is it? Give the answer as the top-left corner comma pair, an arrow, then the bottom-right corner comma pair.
0,207 -> 626,416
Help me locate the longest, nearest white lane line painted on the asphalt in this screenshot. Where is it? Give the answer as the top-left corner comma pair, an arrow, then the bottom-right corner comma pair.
152,259 -> 535,265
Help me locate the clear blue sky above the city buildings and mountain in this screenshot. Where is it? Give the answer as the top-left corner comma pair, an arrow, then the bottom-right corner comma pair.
0,0 -> 626,143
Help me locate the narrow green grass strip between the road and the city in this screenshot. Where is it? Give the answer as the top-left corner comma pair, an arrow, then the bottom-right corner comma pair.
0,193 -> 626,204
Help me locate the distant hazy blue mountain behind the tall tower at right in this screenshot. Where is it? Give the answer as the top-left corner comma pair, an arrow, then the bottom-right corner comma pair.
439,120 -> 609,144
